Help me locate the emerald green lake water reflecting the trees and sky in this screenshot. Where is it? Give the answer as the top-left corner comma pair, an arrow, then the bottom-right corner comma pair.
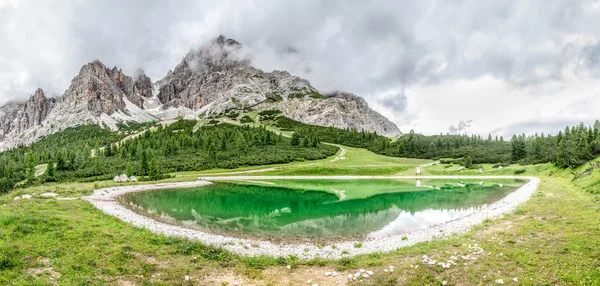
122,179 -> 525,238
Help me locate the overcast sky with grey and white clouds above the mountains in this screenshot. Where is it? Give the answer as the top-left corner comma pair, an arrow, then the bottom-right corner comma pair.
0,0 -> 600,136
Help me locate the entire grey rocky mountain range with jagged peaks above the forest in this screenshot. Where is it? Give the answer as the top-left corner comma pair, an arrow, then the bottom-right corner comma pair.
0,36 -> 402,150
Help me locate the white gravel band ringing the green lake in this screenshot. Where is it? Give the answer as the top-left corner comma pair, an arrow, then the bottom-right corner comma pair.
83,176 -> 540,259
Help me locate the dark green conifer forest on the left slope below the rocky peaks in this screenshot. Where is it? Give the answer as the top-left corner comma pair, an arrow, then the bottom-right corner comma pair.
0,120 -> 338,192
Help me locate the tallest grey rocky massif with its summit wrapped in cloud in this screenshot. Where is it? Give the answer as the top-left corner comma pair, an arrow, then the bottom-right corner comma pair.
158,36 -> 402,136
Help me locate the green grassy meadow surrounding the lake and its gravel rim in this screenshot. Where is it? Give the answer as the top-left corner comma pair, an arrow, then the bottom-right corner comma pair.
0,142 -> 600,285
